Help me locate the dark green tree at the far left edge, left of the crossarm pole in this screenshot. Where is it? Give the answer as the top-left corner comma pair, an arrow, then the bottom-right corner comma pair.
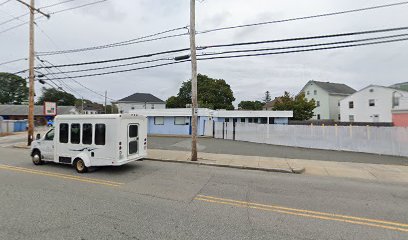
0,72 -> 28,104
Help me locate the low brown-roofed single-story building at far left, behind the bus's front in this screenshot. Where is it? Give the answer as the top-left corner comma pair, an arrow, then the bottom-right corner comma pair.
0,104 -> 79,126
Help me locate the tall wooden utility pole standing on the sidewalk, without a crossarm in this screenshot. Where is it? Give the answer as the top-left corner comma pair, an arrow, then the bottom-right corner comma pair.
190,0 -> 197,161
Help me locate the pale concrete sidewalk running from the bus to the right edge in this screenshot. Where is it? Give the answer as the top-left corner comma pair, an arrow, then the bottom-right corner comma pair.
148,149 -> 408,183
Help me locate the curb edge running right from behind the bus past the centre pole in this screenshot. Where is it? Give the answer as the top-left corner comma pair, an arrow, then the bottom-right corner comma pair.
144,158 -> 305,174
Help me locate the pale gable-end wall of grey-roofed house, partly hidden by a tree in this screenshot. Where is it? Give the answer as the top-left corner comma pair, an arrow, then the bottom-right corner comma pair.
303,83 -> 330,119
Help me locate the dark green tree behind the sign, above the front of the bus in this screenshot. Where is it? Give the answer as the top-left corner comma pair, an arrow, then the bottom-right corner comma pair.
37,87 -> 76,106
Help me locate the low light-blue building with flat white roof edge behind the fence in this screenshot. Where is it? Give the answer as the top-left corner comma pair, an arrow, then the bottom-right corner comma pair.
130,108 -> 293,135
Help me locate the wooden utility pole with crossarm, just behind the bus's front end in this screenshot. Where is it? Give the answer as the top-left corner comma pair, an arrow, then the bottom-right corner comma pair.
17,0 -> 50,146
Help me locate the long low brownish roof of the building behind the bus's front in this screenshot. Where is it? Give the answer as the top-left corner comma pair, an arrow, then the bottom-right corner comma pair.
0,105 -> 77,116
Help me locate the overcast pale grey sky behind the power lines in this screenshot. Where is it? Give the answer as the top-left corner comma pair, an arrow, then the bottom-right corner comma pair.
0,0 -> 408,106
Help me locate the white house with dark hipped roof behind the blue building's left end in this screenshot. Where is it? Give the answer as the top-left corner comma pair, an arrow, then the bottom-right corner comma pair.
114,93 -> 166,113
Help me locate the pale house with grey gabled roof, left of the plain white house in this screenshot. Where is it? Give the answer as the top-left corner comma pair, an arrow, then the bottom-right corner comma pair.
301,81 -> 356,120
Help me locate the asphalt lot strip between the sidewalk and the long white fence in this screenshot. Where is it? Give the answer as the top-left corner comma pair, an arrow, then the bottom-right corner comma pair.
148,137 -> 408,166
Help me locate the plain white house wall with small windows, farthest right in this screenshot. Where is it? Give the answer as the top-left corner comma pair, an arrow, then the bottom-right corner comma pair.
340,86 -> 408,122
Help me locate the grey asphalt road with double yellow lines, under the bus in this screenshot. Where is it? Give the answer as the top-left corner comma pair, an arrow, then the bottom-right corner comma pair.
0,148 -> 408,240
